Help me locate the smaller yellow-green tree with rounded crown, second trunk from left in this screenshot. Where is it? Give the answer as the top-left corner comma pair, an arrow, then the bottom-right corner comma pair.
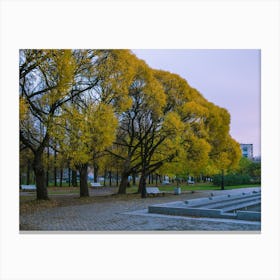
52,103 -> 117,197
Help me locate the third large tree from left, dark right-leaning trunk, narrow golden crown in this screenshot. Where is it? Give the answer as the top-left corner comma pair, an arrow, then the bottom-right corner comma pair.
106,57 -> 165,193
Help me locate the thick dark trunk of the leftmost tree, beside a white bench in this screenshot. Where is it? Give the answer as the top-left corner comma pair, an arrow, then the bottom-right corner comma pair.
33,152 -> 49,200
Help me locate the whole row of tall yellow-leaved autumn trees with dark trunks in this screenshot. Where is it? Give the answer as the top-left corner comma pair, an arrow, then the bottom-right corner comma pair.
19,50 -> 241,199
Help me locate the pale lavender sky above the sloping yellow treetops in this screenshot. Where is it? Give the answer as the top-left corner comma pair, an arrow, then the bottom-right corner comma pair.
132,49 -> 261,156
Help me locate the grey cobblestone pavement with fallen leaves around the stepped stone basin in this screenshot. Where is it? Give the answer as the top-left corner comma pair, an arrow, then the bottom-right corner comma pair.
20,188 -> 260,232
